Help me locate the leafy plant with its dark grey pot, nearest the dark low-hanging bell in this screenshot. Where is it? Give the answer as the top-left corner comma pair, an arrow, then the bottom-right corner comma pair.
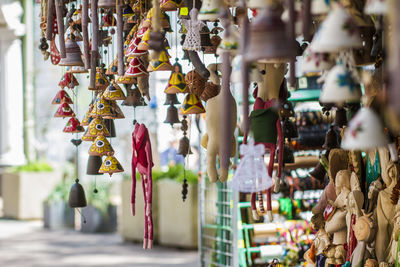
81,183 -> 117,233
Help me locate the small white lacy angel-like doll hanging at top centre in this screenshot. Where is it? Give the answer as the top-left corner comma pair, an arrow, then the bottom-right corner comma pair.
181,8 -> 205,51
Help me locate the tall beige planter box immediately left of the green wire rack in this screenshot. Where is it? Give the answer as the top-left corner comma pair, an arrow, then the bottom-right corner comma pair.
158,179 -> 198,249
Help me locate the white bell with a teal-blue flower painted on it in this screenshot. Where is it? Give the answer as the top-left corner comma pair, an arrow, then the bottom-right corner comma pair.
319,63 -> 361,106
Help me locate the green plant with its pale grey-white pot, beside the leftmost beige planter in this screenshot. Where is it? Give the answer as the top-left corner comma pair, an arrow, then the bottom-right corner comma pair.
43,179 -> 75,230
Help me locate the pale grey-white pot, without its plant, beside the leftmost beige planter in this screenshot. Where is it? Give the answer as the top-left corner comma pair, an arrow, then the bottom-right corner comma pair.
43,201 -> 75,230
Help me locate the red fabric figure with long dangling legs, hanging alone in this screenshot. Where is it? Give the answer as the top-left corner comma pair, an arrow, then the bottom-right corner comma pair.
131,123 -> 154,249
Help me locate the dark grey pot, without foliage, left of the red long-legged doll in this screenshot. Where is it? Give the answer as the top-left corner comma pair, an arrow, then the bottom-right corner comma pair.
81,205 -> 117,233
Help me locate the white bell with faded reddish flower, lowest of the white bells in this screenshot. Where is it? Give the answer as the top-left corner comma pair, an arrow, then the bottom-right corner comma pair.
342,108 -> 388,150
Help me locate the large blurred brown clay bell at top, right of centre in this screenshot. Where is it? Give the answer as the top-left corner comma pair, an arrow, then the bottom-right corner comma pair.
244,6 -> 298,62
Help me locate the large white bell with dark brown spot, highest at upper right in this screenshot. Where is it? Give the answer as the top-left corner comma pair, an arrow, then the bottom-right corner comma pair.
311,5 -> 362,53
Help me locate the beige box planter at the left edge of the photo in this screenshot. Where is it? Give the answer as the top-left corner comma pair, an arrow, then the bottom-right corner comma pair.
1,172 -> 62,219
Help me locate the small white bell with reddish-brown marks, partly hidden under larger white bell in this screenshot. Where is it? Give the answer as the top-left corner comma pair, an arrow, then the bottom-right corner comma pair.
301,47 -> 335,74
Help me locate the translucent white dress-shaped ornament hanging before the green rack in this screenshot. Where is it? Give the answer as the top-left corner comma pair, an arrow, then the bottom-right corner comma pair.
232,139 -> 272,193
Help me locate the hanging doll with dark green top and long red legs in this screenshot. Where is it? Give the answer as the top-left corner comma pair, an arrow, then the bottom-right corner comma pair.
245,64 -> 286,221
